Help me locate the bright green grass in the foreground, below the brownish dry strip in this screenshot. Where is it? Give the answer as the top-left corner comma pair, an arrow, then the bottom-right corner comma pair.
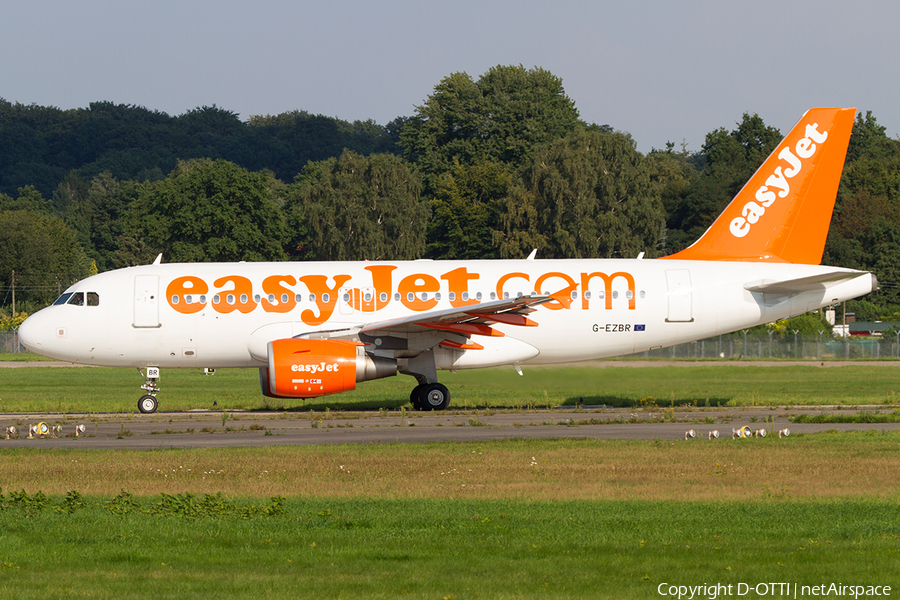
0,498 -> 900,599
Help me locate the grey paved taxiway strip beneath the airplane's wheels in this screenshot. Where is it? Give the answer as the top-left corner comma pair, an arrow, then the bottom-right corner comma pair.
0,407 -> 900,450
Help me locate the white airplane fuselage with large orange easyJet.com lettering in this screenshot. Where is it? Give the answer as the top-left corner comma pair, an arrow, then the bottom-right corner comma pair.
20,259 -> 876,369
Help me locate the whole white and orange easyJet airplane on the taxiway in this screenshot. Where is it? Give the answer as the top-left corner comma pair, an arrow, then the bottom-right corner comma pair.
19,108 -> 877,413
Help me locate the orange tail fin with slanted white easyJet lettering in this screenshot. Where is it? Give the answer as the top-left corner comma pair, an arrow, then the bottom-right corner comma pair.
665,108 -> 856,265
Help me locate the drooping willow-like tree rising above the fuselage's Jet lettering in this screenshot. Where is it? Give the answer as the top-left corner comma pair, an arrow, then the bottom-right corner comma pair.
286,150 -> 429,260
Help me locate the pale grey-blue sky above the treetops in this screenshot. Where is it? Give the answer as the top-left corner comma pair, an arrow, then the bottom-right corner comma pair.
0,0 -> 900,152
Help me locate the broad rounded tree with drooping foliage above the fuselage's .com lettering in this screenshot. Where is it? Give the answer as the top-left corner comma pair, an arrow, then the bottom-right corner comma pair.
498,128 -> 665,258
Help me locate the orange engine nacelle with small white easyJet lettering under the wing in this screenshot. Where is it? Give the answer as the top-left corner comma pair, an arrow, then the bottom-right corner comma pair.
259,338 -> 397,398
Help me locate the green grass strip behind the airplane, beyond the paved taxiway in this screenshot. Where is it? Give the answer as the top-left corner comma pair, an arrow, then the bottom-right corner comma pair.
0,364 -> 900,412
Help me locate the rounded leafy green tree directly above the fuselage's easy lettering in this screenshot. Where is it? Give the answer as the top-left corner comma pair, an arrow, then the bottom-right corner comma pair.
121,159 -> 286,262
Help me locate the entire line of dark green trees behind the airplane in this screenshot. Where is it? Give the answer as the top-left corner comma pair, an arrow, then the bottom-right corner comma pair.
0,66 -> 900,319
